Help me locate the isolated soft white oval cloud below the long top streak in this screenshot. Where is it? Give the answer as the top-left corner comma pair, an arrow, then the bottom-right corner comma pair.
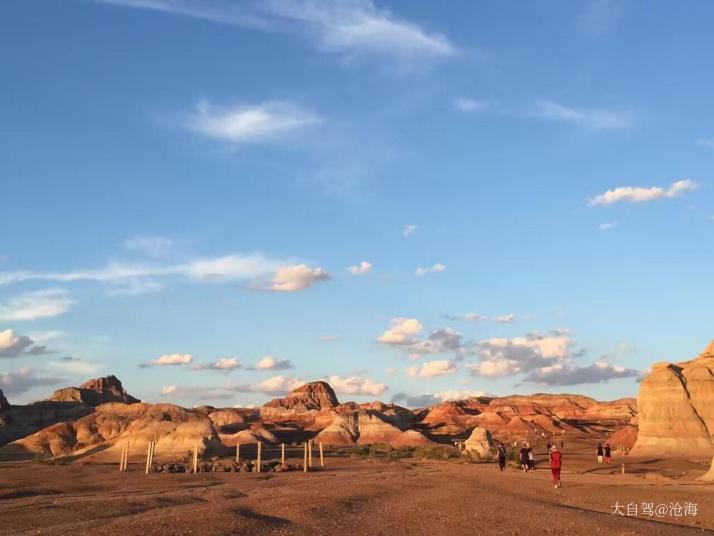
185,101 -> 322,143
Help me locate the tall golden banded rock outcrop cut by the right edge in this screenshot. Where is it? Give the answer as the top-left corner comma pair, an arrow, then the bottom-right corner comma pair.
632,341 -> 714,457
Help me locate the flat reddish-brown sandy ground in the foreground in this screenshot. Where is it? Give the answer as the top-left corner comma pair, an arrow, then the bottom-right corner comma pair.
0,447 -> 714,536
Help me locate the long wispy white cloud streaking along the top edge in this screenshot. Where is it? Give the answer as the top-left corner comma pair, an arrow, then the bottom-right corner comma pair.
97,0 -> 459,71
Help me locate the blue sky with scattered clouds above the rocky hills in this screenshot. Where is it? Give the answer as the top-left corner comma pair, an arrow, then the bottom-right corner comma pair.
0,0 -> 714,405
